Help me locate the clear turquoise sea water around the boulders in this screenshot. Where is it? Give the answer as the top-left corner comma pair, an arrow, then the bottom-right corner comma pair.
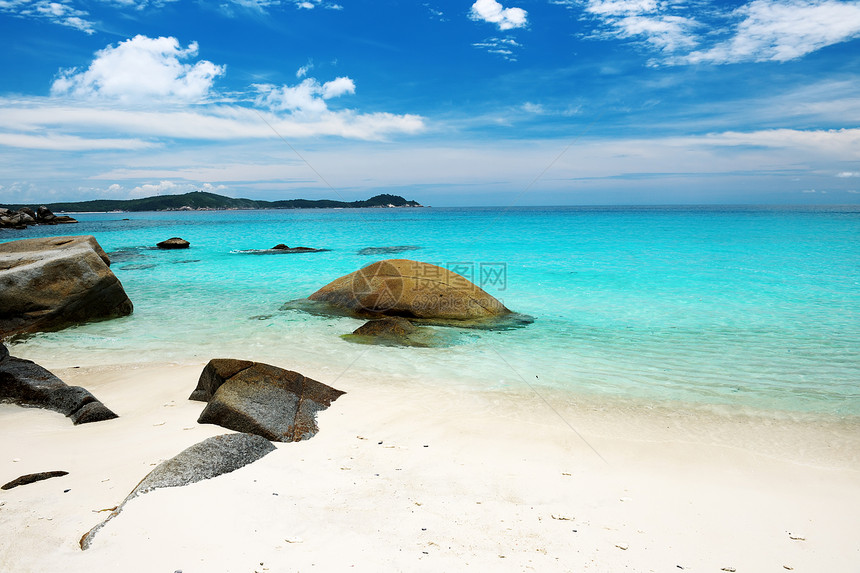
0,206 -> 860,416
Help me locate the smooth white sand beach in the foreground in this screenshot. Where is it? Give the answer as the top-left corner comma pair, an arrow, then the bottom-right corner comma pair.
0,363 -> 860,573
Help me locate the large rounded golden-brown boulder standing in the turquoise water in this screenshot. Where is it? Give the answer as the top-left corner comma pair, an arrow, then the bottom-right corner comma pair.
308,259 -> 511,320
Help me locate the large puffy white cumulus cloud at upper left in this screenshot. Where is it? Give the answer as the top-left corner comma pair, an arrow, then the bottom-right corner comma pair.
51,35 -> 225,102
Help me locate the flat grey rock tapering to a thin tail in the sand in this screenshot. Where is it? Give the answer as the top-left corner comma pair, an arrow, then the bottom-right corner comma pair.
80,434 -> 276,550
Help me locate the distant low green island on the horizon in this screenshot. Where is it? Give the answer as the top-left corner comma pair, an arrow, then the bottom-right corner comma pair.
0,191 -> 422,213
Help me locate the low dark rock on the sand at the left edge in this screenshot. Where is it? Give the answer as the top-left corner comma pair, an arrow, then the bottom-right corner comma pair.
0,356 -> 118,425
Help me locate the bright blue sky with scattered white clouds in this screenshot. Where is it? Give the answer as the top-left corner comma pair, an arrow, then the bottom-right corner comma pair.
0,0 -> 860,207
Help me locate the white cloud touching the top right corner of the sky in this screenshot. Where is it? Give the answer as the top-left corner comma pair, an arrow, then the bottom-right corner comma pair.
686,0 -> 860,64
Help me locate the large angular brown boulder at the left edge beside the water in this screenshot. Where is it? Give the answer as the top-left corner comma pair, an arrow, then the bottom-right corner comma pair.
0,235 -> 134,338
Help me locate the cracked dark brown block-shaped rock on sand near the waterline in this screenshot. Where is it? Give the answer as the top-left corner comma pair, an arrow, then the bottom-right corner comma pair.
189,358 -> 344,442
